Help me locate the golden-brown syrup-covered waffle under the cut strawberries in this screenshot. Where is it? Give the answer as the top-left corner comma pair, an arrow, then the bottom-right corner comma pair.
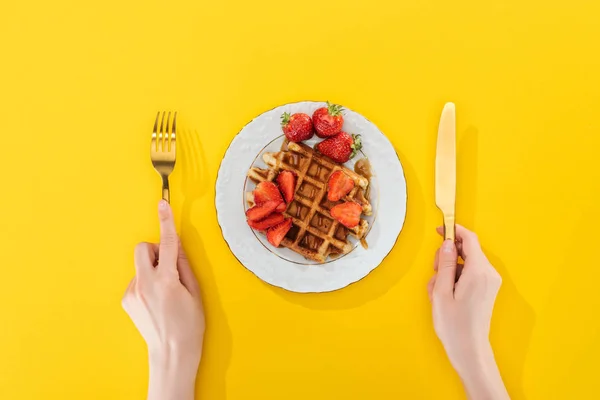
247,143 -> 372,262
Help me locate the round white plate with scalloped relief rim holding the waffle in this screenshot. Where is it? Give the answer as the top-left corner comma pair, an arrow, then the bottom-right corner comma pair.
216,101 -> 406,293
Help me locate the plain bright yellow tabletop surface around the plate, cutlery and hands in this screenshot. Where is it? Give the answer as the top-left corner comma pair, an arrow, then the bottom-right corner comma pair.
0,0 -> 600,400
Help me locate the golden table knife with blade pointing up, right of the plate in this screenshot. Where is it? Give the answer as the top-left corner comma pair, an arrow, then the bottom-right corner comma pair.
435,103 -> 456,241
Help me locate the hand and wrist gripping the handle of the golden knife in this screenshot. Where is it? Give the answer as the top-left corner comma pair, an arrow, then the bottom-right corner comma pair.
428,226 -> 509,399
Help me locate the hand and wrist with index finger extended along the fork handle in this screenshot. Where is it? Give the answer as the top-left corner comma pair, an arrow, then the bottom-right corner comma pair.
122,200 -> 205,400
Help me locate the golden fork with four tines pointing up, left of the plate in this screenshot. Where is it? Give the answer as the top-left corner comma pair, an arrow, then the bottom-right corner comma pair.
150,111 -> 177,203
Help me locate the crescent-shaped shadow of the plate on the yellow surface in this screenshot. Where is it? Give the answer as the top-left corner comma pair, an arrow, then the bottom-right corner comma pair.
267,150 -> 426,310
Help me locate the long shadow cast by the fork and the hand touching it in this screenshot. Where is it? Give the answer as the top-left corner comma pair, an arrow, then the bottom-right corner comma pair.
179,130 -> 232,400
